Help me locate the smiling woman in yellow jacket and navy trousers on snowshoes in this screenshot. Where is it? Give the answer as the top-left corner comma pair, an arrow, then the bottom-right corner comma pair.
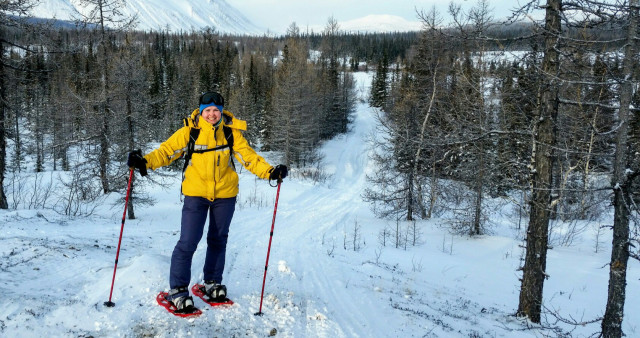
127,92 -> 287,313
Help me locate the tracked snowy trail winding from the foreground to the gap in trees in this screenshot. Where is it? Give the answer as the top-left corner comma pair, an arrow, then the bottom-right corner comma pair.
256,92 -> 385,337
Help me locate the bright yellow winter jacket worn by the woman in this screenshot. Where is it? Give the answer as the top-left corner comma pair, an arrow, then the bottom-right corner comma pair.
144,109 -> 273,201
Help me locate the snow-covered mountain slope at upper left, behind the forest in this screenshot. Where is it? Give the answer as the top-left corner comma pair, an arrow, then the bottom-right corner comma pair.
32,0 -> 266,35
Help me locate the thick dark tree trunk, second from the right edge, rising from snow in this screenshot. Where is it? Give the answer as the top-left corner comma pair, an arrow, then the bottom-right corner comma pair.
517,0 -> 562,323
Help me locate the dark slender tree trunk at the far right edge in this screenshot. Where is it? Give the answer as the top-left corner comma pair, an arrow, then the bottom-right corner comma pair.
602,0 -> 638,337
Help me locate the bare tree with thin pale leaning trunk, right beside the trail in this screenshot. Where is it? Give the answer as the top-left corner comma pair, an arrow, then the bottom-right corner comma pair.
363,10 -> 454,220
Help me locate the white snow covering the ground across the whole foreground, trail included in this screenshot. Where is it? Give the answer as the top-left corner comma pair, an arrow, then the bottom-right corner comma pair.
0,73 -> 640,337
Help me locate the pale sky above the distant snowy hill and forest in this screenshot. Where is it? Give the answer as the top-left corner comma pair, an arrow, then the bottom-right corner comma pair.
226,0 -> 523,32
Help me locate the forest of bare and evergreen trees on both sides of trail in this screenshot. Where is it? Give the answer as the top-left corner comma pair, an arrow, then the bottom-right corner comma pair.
0,0 -> 640,337
